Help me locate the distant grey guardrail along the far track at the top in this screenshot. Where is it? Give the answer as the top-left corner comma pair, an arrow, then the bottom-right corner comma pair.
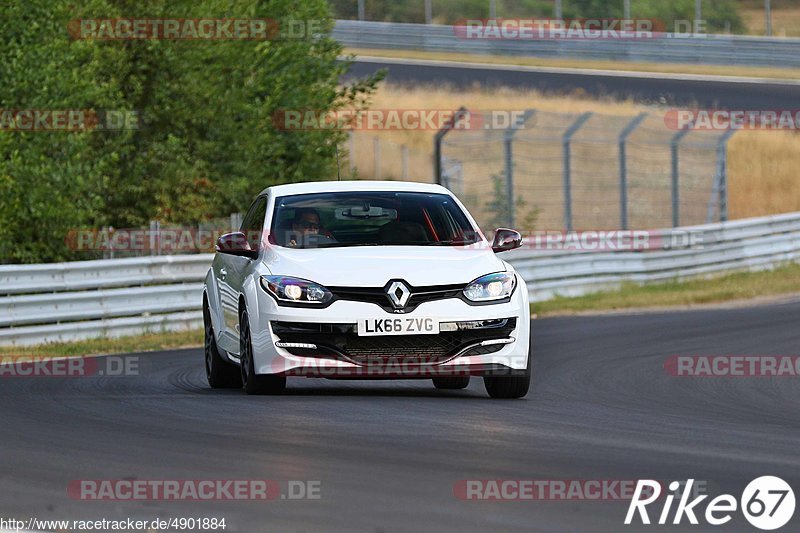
333,20 -> 800,67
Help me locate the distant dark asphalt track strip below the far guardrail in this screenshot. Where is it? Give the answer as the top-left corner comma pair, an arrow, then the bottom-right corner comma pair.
344,58 -> 800,110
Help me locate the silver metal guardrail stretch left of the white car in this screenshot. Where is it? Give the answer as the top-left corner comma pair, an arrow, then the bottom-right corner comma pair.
0,254 -> 212,345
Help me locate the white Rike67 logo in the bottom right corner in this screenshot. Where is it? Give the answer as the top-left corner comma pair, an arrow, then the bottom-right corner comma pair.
625,476 -> 795,531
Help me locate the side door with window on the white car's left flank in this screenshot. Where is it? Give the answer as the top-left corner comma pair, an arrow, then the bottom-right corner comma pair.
217,196 -> 267,340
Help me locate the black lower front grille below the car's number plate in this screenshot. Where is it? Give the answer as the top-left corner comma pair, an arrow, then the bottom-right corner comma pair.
272,318 -> 517,365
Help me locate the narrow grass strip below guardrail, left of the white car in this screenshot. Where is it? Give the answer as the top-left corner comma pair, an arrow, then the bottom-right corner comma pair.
0,329 -> 203,359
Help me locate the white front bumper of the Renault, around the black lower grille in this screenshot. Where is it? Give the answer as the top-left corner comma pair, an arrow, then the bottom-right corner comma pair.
250,284 -> 530,379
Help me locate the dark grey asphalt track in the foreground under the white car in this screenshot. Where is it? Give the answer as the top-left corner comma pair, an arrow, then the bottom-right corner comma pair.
0,302 -> 800,532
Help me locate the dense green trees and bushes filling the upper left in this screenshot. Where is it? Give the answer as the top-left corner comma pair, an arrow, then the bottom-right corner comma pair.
0,0 -> 380,263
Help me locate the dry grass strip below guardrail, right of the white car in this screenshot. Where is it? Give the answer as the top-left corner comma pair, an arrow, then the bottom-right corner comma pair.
531,264 -> 800,316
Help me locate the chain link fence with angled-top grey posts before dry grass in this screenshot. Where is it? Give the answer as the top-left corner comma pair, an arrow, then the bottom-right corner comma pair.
434,109 -> 731,231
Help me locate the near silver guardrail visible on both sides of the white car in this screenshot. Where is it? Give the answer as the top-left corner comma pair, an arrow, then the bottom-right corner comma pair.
0,213 -> 800,345
